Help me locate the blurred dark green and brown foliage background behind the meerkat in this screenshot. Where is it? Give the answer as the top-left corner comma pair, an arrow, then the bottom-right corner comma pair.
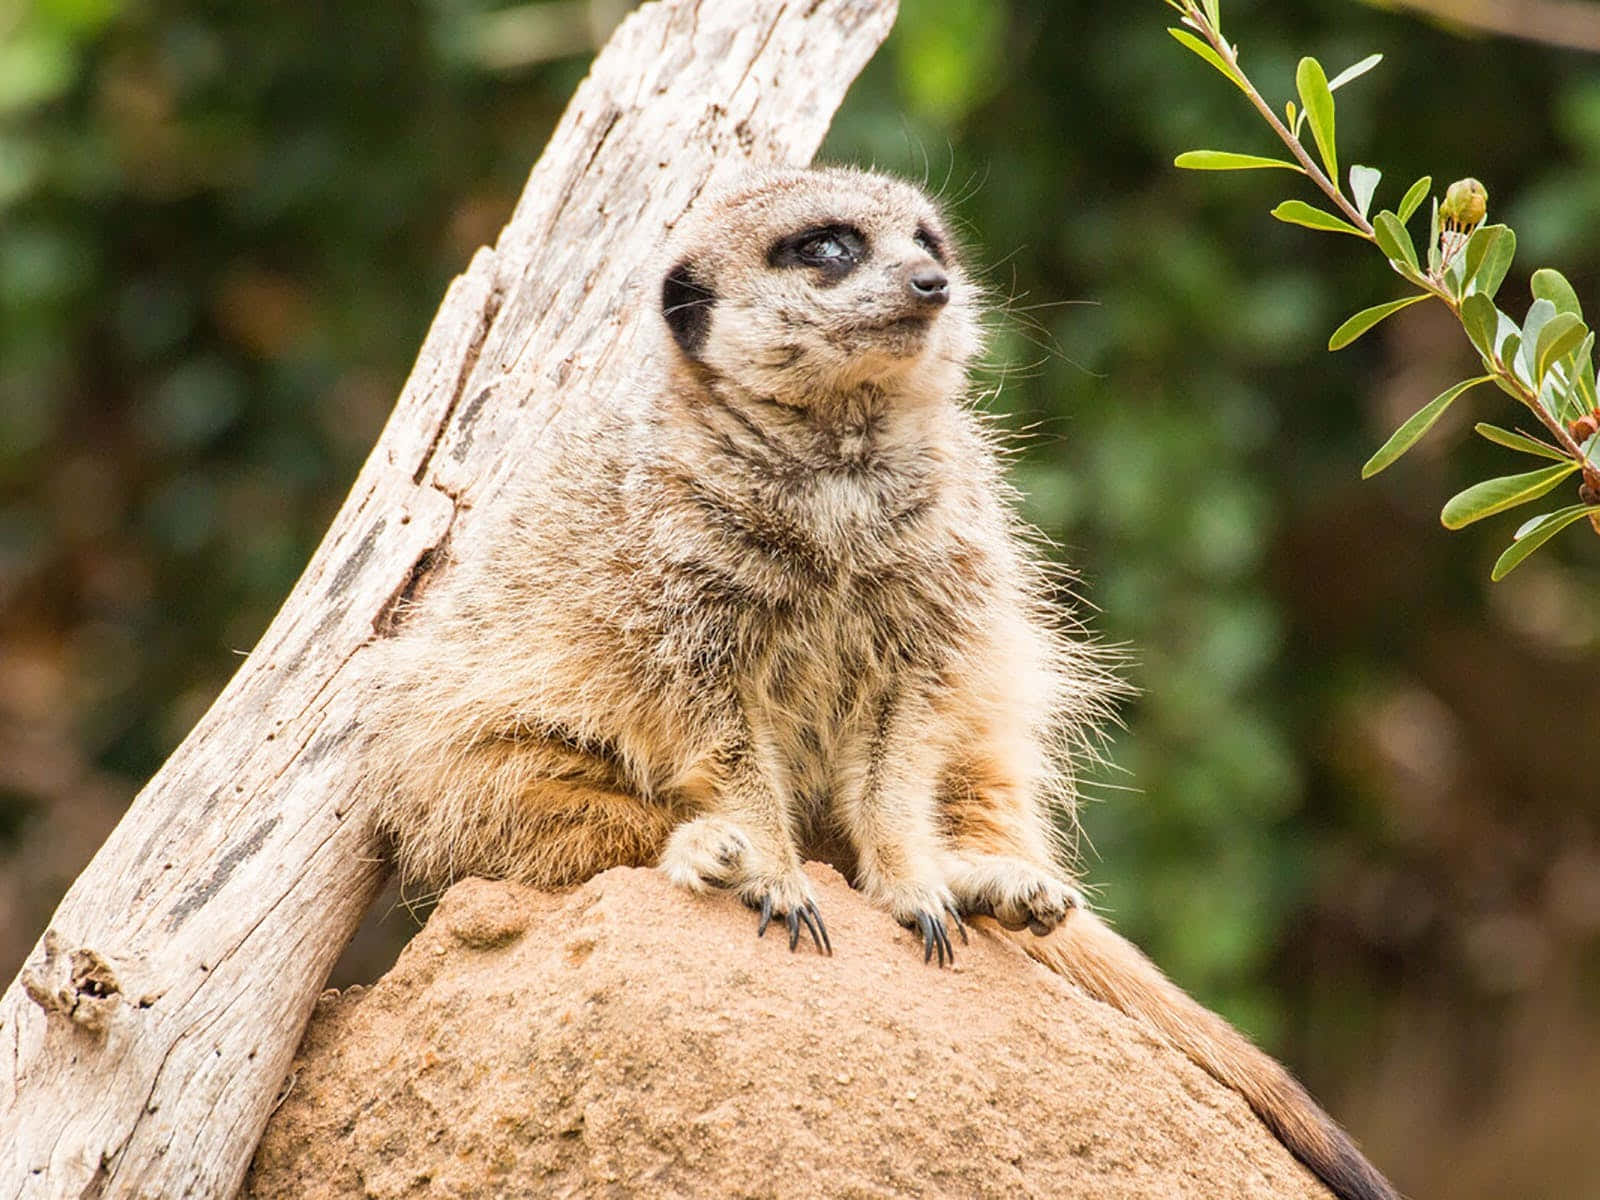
0,0 -> 1600,1198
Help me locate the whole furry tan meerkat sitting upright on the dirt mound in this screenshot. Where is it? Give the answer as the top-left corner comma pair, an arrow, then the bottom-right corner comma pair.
362,168 -> 1395,1200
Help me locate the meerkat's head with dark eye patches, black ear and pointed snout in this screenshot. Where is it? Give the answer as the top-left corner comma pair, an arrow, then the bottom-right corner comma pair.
661,168 -> 979,406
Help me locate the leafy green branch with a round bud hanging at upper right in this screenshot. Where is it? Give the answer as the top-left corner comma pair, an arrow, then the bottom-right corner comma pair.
1165,0 -> 1600,579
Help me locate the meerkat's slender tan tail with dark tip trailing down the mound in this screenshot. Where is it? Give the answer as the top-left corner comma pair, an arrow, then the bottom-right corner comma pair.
1006,909 -> 1400,1200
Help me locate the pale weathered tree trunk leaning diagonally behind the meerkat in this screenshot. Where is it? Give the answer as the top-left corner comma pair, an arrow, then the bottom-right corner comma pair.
0,0 -> 894,1197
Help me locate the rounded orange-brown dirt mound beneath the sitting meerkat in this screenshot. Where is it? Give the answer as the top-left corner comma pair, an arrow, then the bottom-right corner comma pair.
245,866 -> 1328,1200
